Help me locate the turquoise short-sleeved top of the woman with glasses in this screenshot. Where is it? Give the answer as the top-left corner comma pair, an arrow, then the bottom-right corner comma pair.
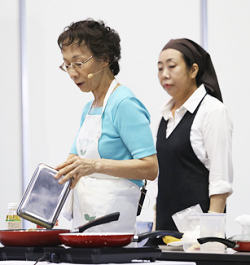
70,86 -> 156,187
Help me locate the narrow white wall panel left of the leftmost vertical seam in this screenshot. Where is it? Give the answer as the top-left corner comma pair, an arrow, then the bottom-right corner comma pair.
0,0 -> 22,229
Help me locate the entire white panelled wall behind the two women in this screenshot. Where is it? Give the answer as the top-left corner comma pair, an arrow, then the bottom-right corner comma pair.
0,0 -> 250,236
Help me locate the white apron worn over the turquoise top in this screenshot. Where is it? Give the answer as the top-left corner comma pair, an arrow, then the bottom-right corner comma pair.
63,79 -> 140,233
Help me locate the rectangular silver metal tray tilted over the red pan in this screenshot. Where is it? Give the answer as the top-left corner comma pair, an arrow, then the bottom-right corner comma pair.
17,164 -> 72,228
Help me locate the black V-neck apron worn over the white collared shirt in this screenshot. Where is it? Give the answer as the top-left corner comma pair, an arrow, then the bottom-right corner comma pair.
156,96 -> 210,230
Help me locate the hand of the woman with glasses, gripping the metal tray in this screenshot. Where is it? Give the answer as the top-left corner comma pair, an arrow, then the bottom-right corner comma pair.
55,154 -> 95,189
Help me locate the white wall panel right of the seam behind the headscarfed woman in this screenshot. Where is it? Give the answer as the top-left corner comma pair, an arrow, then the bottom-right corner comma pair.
208,0 -> 250,236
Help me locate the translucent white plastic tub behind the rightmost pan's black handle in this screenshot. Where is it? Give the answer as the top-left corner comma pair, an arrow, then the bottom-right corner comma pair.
200,213 -> 226,253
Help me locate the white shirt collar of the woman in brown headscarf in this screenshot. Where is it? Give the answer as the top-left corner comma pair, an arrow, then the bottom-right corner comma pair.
161,85 -> 207,120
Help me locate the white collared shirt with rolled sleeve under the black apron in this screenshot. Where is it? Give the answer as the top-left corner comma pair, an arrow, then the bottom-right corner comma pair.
159,85 -> 233,196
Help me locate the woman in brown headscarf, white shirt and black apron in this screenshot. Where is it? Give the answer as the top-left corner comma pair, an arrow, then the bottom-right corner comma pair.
156,39 -> 233,230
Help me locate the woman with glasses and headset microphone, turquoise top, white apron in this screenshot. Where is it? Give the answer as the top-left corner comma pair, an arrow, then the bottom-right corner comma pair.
55,19 -> 158,233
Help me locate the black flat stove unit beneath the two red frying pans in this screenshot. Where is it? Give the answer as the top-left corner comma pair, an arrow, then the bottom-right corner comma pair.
0,246 -> 162,264
